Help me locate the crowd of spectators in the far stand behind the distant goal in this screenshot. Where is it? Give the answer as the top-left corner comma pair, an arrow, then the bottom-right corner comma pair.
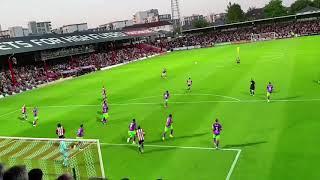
155,20 -> 320,50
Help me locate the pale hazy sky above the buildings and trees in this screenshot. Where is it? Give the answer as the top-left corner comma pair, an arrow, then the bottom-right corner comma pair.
0,0 -> 294,30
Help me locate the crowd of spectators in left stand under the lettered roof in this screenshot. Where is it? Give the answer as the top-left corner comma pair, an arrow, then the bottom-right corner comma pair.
0,44 -> 161,96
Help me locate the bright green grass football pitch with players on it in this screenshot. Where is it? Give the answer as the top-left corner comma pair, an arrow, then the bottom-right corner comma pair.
0,36 -> 320,180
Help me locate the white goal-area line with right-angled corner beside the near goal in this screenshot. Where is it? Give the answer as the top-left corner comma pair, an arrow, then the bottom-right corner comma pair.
100,143 -> 242,180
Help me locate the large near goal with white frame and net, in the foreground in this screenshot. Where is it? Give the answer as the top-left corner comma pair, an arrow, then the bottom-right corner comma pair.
0,137 -> 105,180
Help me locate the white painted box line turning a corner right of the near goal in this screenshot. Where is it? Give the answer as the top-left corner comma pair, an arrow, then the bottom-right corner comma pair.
101,143 -> 242,180
